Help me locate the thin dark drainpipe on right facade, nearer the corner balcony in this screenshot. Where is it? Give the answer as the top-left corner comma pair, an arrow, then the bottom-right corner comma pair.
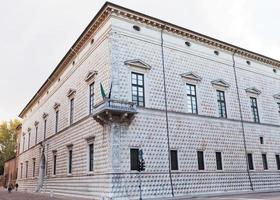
160,25 -> 174,197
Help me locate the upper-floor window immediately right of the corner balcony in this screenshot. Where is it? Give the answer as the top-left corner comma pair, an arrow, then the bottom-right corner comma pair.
131,72 -> 145,106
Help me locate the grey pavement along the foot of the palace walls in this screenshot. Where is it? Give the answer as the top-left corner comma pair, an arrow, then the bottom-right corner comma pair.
0,190 -> 280,200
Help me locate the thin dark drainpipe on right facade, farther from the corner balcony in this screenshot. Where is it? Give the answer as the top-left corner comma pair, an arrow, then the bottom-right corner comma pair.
232,49 -> 254,190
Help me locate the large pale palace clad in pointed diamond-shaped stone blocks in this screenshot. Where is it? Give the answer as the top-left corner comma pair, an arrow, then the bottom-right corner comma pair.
17,2 -> 280,199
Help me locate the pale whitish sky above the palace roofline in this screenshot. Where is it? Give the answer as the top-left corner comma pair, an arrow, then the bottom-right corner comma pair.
0,0 -> 280,121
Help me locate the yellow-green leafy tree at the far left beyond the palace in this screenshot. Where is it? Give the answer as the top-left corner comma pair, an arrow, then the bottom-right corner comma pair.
0,119 -> 21,174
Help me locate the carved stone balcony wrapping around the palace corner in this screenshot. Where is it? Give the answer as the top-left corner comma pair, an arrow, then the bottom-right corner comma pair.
92,98 -> 137,125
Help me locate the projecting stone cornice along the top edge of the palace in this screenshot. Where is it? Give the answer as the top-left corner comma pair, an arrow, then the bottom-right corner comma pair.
19,2 -> 280,117
